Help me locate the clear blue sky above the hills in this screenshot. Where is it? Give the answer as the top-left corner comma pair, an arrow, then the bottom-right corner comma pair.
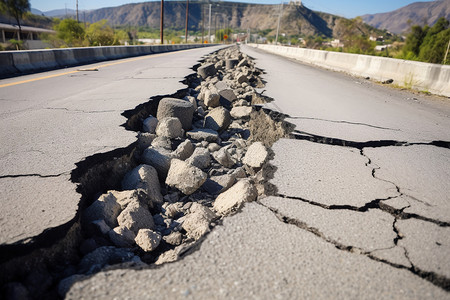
30,0 -> 433,18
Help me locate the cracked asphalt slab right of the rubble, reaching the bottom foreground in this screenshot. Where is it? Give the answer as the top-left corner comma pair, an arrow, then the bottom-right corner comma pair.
67,48 -> 450,299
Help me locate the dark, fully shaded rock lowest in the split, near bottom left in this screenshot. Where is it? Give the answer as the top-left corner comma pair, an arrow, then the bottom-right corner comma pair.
78,246 -> 141,274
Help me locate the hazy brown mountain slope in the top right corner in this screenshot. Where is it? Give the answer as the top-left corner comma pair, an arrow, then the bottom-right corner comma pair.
362,0 -> 450,34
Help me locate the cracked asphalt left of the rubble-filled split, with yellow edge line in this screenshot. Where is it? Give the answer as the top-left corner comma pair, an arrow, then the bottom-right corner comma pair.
0,48 -> 224,245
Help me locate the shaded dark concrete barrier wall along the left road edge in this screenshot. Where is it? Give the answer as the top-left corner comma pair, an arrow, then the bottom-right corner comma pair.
0,44 -> 212,77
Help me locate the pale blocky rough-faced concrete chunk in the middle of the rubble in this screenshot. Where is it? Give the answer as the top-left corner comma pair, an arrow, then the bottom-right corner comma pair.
166,159 -> 207,195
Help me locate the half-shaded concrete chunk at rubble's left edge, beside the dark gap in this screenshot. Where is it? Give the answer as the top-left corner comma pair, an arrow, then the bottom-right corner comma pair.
83,193 -> 121,228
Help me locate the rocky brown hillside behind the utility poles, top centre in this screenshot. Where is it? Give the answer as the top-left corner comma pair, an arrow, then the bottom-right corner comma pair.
81,1 -> 366,37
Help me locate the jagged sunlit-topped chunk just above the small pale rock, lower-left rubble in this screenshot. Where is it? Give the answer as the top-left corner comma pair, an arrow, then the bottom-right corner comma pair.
117,201 -> 155,234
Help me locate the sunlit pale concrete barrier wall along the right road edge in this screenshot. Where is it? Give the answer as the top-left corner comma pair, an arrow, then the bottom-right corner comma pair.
250,44 -> 450,97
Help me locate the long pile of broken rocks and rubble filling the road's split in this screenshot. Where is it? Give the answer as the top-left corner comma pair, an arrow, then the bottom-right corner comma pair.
51,47 -> 288,295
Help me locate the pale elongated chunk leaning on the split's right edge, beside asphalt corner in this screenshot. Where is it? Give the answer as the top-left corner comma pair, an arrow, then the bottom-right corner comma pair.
213,179 -> 257,216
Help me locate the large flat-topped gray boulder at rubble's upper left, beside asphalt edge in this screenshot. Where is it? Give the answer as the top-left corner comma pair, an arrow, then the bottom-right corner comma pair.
156,98 -> 195,131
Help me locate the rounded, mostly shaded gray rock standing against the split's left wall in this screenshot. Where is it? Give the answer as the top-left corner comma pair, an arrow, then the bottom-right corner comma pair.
121,165 -> 163,207
